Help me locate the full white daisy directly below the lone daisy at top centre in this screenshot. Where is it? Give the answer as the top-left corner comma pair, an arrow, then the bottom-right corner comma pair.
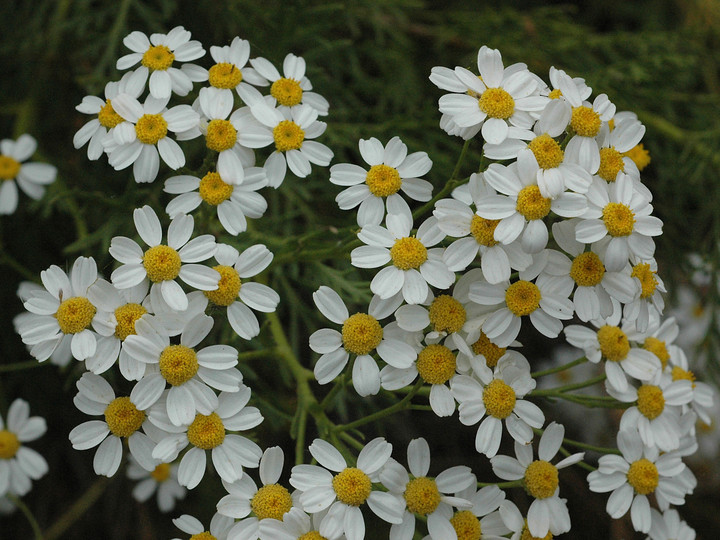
350,208 -> 455,304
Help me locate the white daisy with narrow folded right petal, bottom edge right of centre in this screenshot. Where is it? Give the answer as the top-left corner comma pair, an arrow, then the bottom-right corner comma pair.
490,422 -> 585,538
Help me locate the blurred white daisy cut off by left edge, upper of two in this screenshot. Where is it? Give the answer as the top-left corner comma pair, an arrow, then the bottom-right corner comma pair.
0,134 -> 57,215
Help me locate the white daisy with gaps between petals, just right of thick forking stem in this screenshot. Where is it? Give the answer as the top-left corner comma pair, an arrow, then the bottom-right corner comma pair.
310,285 -> 417,396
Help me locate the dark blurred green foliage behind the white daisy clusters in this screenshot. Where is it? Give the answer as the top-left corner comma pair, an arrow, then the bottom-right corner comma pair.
0,0 -> 720,539
